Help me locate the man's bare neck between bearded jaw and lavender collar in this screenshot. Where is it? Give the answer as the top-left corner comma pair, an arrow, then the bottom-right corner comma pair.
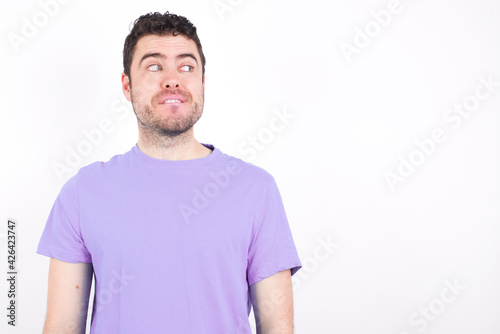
137,128 -> 212,160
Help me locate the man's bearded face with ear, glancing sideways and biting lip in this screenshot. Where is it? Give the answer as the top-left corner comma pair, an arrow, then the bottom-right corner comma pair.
122,35 -> 205,137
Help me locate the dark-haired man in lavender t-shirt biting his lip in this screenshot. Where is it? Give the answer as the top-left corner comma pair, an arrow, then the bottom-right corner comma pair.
37,12 -> 301,334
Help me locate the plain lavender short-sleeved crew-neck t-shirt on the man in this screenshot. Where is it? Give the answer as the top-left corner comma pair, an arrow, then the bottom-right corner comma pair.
37,144 -> 301,334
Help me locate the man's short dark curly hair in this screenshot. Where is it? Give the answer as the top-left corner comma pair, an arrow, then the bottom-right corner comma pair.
123,11 -> 205,77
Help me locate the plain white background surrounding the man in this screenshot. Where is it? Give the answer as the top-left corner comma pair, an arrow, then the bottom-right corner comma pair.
0,0 -> 500,334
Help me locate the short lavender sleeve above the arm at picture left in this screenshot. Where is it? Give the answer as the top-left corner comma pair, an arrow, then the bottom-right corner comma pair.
36,174 -> 92,263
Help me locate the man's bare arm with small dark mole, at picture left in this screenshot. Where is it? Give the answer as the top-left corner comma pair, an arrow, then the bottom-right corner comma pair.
43,258 -> 93,334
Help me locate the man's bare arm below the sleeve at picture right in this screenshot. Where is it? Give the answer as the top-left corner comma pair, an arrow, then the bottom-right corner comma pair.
250,269 -> 293,334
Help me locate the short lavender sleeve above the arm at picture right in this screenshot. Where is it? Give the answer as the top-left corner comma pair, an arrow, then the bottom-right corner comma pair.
247,177 -> 302,286
